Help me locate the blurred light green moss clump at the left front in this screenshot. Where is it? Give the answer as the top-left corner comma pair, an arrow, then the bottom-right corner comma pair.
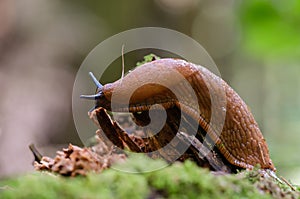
0,170 -> 149,199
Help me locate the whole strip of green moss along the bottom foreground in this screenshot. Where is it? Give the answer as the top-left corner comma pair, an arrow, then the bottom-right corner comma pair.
0,157 -> 298,199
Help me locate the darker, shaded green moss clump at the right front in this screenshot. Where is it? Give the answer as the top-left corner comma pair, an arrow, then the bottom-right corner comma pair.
147,162 -> 271,198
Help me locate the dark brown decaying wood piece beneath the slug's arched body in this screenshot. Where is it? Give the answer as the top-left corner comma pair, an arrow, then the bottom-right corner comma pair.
95,107 -> 235,173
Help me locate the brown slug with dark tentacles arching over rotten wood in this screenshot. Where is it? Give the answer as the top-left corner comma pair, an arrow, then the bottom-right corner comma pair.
81,58 -> 276,171
